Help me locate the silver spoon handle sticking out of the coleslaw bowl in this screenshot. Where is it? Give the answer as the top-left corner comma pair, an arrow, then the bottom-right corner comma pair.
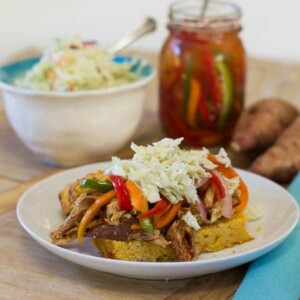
109,17 -> 156,53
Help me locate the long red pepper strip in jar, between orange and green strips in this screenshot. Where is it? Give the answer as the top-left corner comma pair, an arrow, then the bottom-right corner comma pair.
203,50 -> 222,115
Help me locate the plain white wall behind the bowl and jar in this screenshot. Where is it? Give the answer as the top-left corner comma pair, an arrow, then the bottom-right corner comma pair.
0,0 -> 300,64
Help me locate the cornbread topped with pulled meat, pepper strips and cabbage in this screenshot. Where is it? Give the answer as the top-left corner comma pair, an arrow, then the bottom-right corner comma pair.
51,138 -> 252,261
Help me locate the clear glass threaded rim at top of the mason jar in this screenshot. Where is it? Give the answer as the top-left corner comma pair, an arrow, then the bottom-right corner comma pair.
169,0 -> 242,29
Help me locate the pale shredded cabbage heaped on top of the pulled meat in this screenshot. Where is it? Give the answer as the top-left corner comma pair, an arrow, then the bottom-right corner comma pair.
105,138 -> 216,204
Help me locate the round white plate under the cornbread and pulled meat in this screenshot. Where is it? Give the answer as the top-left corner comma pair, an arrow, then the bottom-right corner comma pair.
17,163 -> 299,279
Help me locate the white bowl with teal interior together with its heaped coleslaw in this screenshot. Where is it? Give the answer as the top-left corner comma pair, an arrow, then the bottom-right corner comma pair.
0,40 -> 154,166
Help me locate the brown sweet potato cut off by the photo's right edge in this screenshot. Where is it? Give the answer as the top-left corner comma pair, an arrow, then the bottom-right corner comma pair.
249,117 -> 300,183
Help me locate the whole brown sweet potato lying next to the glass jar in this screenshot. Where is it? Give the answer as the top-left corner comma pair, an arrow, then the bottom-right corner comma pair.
231,98 -> 299,152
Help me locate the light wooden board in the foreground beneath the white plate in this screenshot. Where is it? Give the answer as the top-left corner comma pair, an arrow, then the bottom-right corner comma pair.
0,170 -> 247,300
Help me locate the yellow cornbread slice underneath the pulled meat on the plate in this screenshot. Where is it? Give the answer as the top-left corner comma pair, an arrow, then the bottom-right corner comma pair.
93,214 -> 253,262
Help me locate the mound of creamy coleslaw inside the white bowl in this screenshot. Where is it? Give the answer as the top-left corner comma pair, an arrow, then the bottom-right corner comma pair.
15,38 -> 137,91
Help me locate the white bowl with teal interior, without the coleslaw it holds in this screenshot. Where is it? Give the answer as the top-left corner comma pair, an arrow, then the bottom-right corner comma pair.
0,57 -> 154,166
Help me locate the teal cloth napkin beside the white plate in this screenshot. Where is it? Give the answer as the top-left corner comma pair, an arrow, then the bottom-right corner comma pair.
233,173 -> 300,300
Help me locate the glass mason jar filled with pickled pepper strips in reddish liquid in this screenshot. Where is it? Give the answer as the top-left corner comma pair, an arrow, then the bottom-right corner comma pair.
159,0 -> 246,147
